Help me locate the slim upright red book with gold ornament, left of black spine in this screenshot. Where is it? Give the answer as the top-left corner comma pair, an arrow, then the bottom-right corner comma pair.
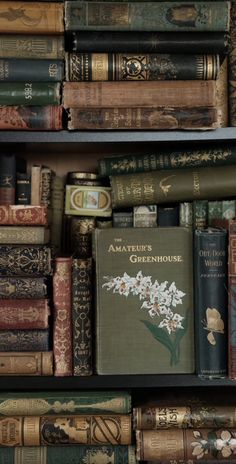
53,257 -> 72,377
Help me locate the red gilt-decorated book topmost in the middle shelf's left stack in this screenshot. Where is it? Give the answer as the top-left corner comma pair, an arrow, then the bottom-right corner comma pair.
0,205 -> 48,226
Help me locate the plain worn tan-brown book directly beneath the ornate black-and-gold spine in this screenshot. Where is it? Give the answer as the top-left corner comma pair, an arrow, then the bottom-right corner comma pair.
62,80 -> 216,108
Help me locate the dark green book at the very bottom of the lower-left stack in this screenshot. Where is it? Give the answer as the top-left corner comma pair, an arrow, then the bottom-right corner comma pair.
0,445 -> 137,464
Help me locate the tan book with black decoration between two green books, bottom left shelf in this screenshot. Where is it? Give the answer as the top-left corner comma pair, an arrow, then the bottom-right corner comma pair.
0,414 -> 132,446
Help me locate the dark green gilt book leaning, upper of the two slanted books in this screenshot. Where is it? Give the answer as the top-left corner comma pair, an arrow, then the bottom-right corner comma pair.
97,147 -> 236,177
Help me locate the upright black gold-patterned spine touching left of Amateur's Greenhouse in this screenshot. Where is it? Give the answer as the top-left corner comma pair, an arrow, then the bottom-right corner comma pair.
72,258 -> 93,376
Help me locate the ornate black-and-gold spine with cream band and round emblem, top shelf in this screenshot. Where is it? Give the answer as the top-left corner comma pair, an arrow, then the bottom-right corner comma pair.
66,53 -> 220,82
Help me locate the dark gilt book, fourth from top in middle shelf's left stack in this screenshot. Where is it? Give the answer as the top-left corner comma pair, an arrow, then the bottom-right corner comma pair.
0,276 -> 47,299
